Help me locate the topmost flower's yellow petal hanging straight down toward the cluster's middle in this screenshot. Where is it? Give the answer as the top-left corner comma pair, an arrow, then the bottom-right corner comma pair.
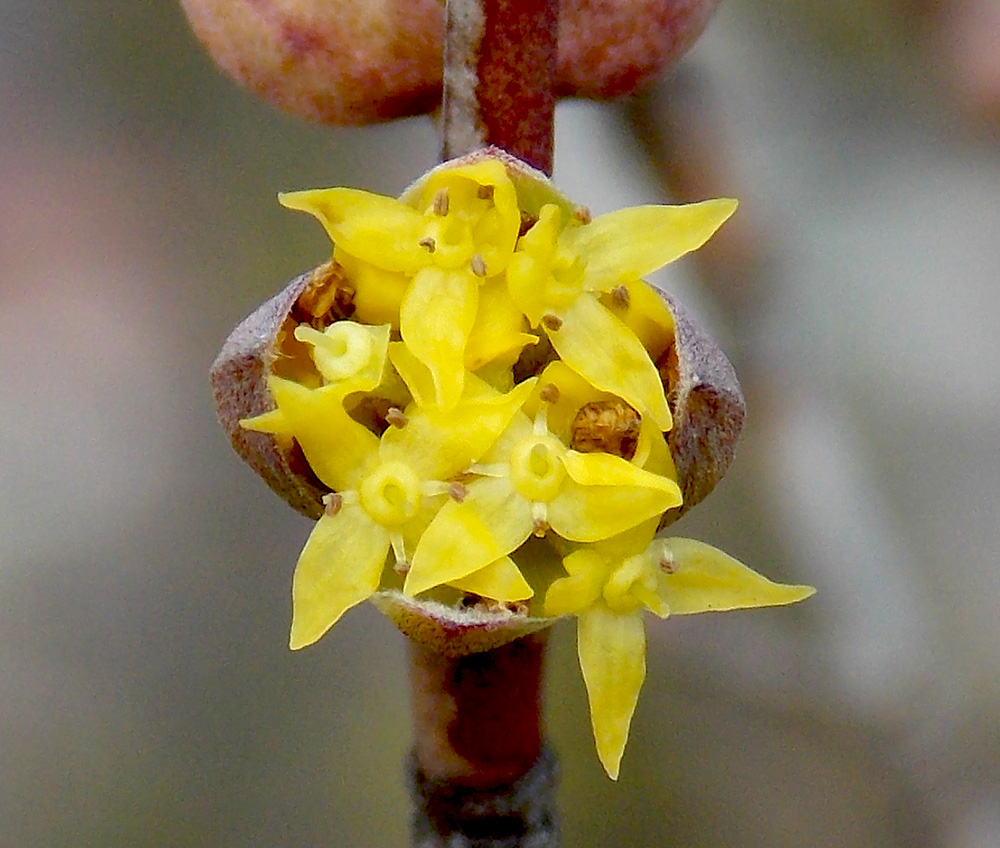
399,267 -> 479,409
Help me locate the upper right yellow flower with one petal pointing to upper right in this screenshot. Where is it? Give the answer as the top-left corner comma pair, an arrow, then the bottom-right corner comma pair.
507,195 -> 736,430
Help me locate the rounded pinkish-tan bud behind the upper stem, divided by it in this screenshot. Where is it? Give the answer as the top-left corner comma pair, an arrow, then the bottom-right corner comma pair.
181,0 -> 718,124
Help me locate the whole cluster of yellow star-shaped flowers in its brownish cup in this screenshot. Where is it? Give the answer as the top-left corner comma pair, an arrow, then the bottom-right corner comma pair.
214,151 -> 812,777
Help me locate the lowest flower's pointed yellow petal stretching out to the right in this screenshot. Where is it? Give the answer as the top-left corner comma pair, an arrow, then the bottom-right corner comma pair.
650,538 -> 816,615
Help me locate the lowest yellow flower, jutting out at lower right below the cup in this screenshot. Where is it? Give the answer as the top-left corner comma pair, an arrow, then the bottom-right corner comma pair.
545,520 -> 815,779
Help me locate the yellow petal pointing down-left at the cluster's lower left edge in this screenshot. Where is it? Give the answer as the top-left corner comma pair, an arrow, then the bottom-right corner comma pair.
289,504 -> 389,651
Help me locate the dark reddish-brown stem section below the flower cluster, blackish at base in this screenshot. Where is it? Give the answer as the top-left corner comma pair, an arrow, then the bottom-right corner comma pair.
410,633 -> 558,848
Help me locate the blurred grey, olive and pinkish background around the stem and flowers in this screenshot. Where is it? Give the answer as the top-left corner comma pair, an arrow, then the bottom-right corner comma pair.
0,0 -> 1000,848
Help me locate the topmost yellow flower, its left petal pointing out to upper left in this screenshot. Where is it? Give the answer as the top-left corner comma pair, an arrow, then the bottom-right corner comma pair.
280,159 -> 534,409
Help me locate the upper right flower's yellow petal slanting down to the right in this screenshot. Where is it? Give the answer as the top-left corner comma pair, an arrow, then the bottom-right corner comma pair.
549,294 -> 671,430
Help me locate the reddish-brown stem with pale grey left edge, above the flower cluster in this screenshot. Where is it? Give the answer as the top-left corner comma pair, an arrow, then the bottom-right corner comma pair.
442,0 -> 559,175
